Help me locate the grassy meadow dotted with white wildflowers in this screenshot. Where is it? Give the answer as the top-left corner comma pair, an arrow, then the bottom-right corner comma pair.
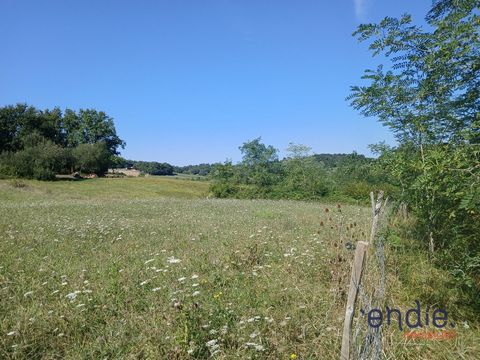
0,177 -> 480,359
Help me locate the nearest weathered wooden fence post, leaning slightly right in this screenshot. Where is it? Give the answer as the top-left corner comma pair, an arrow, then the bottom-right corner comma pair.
340,241 -> 368,360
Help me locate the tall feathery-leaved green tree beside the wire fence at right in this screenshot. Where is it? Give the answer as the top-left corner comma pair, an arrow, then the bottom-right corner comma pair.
349,0 -> 480,304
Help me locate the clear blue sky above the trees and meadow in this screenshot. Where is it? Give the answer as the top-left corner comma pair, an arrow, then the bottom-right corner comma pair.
0,0 -> 431,165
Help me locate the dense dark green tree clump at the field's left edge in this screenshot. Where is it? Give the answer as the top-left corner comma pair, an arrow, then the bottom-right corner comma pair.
0,104 -> 125,180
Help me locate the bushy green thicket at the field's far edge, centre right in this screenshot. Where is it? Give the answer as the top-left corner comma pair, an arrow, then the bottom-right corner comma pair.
210,137 -> 397,200
